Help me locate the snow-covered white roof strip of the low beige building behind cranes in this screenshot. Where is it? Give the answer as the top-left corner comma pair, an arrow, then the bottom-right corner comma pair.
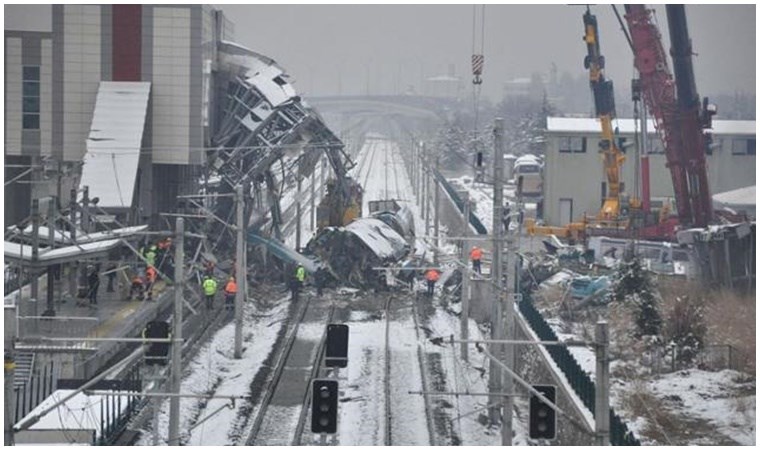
546,117 -> 755,136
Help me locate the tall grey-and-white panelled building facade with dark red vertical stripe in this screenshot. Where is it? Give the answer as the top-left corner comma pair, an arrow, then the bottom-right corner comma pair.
5,4 -> 232,225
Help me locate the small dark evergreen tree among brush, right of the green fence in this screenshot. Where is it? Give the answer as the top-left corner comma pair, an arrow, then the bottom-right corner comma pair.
612,257 -> 662,338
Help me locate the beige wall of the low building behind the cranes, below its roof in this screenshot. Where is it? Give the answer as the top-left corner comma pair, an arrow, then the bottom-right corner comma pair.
544,127 -> 755,225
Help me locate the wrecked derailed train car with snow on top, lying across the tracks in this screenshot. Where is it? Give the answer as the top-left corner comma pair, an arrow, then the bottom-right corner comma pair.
306,207 -> 415,287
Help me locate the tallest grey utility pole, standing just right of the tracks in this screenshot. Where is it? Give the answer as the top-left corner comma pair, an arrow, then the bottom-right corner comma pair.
488,117 -> 504,428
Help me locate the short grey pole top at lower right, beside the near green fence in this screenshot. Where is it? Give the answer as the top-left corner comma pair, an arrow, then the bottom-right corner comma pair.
594,320 -> 610,445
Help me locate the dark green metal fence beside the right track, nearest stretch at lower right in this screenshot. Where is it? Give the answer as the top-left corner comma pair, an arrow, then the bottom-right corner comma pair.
518,291 -> 641,445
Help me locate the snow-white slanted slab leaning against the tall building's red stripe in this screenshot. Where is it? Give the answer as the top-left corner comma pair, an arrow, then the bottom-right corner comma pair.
80,81 -> 150,208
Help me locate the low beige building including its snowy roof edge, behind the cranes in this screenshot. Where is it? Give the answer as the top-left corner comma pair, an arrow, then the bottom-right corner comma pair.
543,117 -> 755,225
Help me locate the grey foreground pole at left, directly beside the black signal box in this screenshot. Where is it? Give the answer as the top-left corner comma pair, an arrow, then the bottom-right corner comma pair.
169,217 -> 185,445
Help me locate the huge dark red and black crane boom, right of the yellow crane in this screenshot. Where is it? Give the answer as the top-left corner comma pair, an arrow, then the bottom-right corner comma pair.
625,5 -> 712,226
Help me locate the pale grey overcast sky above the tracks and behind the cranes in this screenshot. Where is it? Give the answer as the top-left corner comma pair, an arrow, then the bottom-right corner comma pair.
220,5 -> 756,100
